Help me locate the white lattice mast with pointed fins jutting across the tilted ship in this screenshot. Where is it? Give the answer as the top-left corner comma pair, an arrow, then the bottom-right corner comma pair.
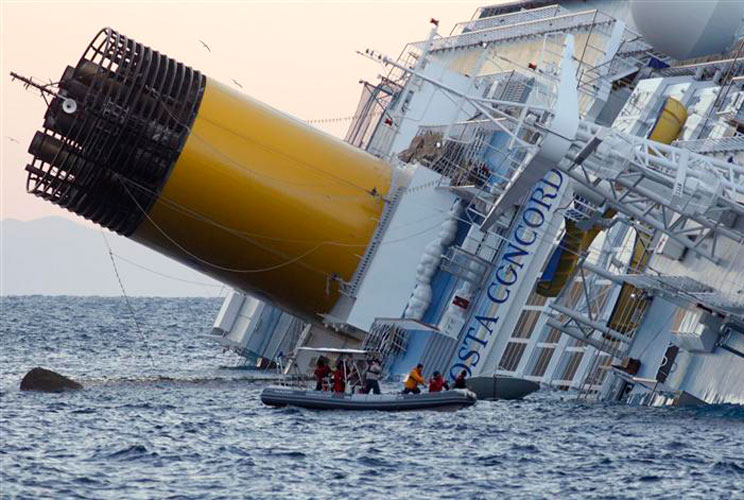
374,35 -> 744,262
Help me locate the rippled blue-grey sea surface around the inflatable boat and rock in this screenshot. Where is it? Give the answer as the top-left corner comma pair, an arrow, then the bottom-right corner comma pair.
0,297 -> 744,499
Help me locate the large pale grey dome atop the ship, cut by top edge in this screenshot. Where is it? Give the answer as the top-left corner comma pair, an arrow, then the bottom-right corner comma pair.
630,0 -> 744,59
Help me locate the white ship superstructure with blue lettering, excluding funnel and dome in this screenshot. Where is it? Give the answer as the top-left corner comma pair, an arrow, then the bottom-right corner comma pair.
205,1 -> 744,404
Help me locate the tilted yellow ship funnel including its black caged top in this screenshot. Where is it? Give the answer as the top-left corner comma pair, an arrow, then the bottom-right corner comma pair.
27,29 -> 391,321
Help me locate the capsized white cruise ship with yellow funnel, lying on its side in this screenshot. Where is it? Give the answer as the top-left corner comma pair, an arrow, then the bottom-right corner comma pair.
16,0 -> 744,405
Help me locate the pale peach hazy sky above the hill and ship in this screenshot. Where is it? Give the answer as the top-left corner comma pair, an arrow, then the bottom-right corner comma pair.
0,0 -> 486,221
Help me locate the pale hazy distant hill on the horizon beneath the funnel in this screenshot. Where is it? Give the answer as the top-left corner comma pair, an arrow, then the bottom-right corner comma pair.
0,217 -> 221,297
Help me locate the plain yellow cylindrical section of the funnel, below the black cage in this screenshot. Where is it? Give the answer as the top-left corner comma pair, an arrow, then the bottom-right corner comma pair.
132,78 -> 391,321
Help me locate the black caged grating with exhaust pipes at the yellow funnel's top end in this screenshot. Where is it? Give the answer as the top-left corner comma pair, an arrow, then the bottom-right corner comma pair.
26,28 -> 206,236
